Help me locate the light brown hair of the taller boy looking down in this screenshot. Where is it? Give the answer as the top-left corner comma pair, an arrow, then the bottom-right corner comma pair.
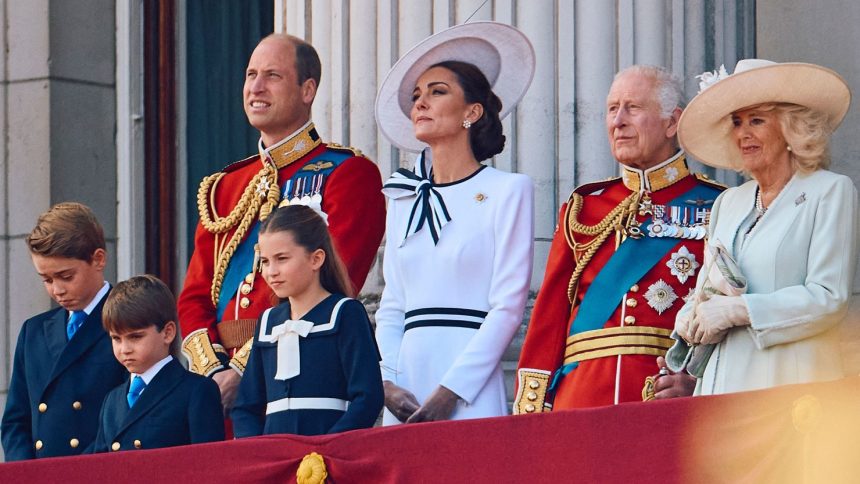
27,202 -> 105,263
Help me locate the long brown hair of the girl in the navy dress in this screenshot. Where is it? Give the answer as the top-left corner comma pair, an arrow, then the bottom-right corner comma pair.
260,205 -> 355,297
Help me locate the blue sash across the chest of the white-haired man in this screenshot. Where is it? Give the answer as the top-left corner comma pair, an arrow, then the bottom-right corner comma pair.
550,184 -> 720,389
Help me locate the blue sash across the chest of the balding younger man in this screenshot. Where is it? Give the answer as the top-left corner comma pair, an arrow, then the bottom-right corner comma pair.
215,150 -> 353,323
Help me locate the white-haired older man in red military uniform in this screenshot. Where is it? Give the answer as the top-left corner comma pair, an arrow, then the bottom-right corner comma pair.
513,66 -> 722,414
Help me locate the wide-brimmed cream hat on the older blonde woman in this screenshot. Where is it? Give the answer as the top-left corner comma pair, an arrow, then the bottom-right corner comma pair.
678,59 -> 851,170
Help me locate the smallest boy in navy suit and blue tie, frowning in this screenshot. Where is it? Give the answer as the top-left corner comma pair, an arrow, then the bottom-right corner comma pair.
91,275 -> 224,452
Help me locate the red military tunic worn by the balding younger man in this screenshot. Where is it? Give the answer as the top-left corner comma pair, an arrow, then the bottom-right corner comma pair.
177,123 -> 385,375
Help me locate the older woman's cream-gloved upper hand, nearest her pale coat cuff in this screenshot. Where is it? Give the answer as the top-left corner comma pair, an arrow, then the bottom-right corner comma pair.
689,295 -> 750,344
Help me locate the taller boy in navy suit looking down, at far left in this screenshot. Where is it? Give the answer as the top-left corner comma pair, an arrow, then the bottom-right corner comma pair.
0,203 -> 128,461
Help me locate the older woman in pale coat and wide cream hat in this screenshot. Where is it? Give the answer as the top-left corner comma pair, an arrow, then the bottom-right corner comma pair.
676,59 -> 858,394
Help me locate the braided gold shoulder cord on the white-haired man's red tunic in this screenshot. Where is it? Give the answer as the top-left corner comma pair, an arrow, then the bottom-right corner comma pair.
567,192 -> 639,304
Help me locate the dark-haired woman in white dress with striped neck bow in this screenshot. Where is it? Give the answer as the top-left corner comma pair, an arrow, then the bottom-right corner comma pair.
376,22 -> 534,425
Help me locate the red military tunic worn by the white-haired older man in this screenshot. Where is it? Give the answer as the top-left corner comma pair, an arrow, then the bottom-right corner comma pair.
513,153 -> 722,413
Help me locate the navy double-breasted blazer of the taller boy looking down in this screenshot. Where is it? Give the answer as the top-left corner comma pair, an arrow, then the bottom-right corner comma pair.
0,296 -> 128,461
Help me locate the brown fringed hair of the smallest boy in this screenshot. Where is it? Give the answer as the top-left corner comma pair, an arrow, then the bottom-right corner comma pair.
102,274 -> 182,356
